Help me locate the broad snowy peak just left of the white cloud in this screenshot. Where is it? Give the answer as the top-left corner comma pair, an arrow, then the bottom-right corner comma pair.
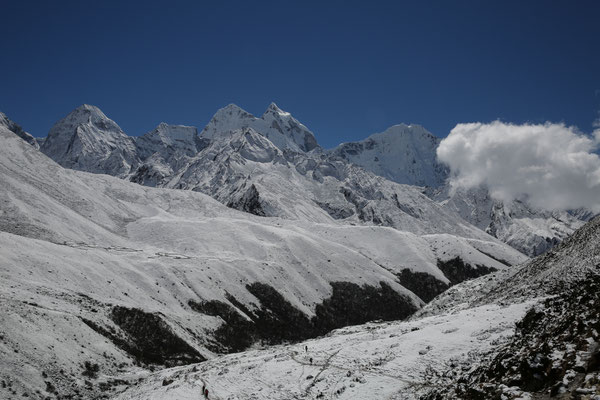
331,124 -> 448,187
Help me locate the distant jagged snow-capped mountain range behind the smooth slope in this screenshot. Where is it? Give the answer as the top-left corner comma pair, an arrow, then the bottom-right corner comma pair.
34,103 -> 591,256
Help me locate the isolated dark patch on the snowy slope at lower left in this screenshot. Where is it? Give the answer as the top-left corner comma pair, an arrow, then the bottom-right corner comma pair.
110,306 -> 205,366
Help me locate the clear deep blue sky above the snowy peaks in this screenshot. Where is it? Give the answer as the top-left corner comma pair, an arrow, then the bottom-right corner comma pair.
0,0 -> 600,147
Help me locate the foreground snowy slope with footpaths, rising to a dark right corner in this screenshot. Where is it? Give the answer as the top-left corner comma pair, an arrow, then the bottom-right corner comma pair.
117,218 -> 600,400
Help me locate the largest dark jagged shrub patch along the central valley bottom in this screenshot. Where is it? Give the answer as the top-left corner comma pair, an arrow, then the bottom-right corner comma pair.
189,282 -> 417,352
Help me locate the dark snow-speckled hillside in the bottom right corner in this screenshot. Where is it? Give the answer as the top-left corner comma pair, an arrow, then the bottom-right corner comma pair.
422,275 -> 600,400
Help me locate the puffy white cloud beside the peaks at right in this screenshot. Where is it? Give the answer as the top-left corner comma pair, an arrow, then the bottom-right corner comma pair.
437,121 -> 600,212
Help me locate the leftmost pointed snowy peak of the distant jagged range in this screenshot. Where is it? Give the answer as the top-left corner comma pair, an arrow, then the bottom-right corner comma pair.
41,104 -> 139,177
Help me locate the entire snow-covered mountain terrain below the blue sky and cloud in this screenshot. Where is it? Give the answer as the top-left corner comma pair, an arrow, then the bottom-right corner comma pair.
0,104 -> 599,399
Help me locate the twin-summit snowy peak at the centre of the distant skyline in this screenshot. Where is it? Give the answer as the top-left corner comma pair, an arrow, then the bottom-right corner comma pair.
201,103 -> 319,152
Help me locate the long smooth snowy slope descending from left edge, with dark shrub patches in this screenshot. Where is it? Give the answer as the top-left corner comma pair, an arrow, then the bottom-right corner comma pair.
0,128 -> 524,398
